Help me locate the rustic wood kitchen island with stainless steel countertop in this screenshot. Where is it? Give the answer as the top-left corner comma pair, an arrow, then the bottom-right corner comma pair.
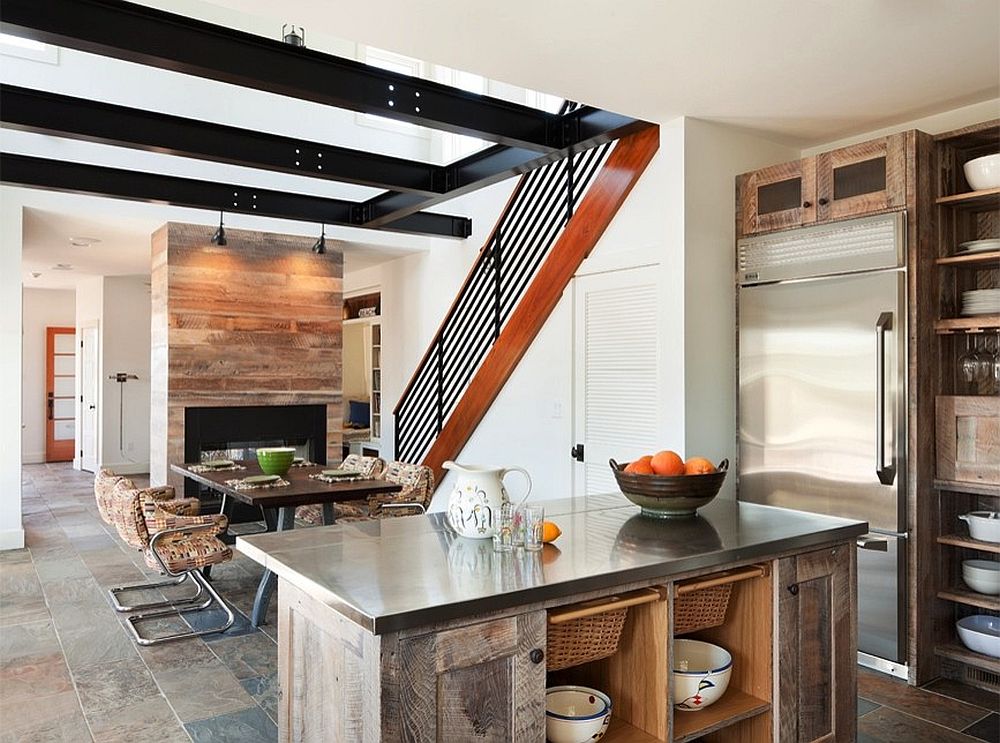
237,494 -> 867,743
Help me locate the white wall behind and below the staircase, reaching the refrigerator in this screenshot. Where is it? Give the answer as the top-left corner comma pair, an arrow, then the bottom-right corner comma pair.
345,119 -> 798,509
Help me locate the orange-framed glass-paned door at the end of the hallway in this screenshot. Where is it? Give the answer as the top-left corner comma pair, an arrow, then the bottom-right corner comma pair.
45,327 -> 76,462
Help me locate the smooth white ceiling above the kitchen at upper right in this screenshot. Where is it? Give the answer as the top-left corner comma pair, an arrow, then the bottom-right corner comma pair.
207,0 -> 1000,146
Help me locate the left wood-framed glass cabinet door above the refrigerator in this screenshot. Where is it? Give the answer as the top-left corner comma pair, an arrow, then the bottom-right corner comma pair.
738,158 -> 816,235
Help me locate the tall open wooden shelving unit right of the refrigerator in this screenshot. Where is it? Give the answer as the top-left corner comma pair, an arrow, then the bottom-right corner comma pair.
925,120 -> 1000,690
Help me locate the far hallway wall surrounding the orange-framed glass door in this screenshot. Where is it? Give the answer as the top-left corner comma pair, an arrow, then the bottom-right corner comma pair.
21,288 -> 76,464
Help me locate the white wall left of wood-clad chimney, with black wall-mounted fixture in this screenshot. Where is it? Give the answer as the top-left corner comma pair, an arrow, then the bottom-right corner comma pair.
74,276 -> 152,474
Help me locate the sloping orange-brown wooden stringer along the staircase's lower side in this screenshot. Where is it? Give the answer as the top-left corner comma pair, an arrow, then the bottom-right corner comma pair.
423,124 -> 660,483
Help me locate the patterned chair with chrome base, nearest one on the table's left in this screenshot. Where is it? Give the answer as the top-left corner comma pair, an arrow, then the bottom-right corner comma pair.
110,481 -> 235,645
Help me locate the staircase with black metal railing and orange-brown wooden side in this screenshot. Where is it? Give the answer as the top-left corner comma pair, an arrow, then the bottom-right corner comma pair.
393,126 -> 659,482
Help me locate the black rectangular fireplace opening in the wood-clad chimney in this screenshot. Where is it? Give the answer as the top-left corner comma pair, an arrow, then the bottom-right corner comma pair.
184,405 -> 327,521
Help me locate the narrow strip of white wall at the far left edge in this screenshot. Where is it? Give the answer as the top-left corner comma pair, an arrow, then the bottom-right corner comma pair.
0,192 -> 24,550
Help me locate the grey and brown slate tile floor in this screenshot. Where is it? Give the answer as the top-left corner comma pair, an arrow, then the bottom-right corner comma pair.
0,465 -> 1000,743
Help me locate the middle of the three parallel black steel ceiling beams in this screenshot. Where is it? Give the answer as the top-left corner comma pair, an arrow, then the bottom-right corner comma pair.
0,85 -> 443,195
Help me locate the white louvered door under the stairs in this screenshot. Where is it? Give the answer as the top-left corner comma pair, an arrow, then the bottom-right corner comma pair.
573,267 -> 663,495
